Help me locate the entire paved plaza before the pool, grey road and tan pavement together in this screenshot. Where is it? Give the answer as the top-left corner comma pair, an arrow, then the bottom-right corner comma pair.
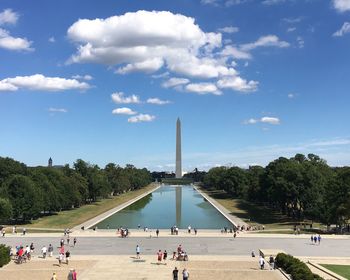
0,230 -> 350,280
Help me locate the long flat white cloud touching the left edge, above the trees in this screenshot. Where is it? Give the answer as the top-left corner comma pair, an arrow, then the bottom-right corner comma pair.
0,74 -> 90,91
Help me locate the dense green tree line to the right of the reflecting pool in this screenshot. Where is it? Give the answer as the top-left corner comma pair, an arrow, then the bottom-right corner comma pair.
203,154 -> 350,229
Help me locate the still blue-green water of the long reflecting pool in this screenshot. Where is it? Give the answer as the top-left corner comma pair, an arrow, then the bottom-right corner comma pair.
96,185 -> 232,229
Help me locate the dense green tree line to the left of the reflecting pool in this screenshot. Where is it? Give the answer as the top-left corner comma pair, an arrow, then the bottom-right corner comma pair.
0,157 -> 152,222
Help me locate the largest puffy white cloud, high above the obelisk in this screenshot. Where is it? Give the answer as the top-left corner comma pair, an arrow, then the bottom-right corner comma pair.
67,11 -> 260,93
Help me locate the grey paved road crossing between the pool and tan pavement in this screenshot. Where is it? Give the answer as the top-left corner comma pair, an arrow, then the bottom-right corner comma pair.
1,233 -> 350,257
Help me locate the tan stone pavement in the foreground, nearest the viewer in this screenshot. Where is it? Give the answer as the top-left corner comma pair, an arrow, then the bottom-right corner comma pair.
0,255 -> 285,280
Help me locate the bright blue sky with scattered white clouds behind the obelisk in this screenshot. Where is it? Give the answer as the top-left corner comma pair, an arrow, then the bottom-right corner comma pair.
0,0 -> 350,171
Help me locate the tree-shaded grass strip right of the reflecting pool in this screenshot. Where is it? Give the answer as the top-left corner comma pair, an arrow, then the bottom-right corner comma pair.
202,189 -> 321,233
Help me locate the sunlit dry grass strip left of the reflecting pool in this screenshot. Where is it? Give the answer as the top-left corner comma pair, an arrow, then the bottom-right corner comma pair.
9,184 -> 156,232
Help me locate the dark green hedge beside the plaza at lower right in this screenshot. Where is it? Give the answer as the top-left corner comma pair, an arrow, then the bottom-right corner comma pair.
276,253 -> 324,280
